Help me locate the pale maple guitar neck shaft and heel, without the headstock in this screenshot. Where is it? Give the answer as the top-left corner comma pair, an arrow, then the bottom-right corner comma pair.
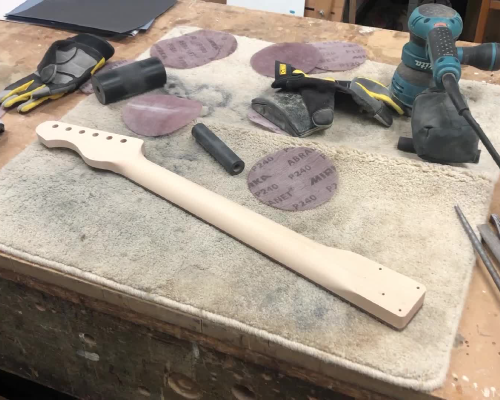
119,157 -> 425,328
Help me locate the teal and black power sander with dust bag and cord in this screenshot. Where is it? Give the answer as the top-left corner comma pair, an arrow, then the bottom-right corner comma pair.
391,4 -> 500,168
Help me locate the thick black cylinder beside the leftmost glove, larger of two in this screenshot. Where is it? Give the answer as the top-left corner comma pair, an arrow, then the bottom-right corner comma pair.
92,57 -> 167,104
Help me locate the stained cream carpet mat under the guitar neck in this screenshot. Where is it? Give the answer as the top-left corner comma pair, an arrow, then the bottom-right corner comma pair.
0,27 -> 500,396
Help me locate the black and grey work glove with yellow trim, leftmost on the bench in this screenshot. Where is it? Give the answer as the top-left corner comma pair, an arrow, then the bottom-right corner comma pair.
0,34 -> 115,113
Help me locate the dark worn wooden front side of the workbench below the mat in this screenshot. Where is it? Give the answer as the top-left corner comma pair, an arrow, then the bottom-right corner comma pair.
0,278 -> 366,400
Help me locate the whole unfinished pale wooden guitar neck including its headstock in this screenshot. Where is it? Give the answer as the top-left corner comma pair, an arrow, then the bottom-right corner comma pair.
37,121 -> 425,329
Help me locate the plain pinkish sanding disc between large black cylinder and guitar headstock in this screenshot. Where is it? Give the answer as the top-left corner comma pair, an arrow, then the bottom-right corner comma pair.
122,94 -> 202,136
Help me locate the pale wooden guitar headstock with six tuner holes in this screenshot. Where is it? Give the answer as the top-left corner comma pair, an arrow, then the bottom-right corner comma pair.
36,121 -> 144,170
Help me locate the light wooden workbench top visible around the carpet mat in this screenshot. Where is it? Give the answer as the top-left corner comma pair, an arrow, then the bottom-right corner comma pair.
0,0 -> 500,399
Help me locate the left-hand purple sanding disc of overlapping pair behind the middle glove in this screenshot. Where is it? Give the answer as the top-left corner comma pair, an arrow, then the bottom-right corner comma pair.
250,43 -> 321,78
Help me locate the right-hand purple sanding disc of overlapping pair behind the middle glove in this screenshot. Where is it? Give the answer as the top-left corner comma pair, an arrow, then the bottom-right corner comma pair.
310,42 -> 366,73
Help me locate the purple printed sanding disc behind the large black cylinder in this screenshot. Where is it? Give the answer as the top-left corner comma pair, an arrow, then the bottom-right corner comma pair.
151,29 -> 238,69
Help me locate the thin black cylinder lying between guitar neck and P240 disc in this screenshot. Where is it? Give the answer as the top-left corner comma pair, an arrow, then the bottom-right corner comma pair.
192,124 -> 245,175
